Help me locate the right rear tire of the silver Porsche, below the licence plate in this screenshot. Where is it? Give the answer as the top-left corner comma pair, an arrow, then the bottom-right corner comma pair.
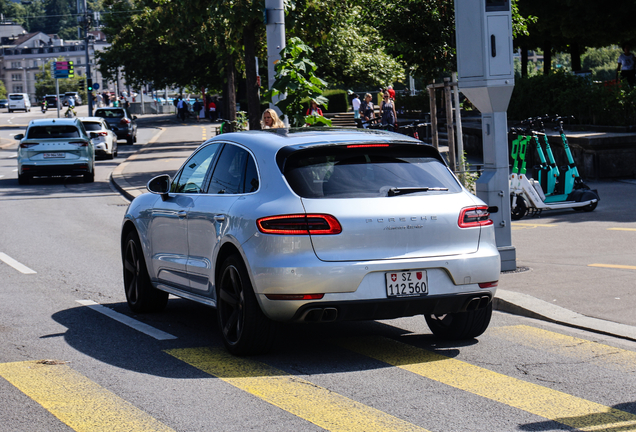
425,302 -> 492,340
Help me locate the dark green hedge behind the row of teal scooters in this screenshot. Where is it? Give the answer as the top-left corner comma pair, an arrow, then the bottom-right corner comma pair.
508,72 -> 636,126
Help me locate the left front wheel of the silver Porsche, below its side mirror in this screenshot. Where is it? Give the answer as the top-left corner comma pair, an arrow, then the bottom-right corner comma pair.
122,231 -> 168,313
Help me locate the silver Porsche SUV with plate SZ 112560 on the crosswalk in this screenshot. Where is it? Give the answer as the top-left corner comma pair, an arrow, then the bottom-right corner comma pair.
121,129 -> 500,355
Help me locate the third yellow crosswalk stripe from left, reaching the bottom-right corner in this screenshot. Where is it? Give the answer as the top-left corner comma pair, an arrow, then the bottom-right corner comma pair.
339,337 -> 636,431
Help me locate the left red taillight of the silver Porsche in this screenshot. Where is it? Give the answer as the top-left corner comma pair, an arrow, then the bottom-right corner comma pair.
256,214 -> 342,235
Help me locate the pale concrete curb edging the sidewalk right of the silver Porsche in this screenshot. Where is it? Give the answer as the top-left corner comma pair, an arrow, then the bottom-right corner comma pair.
493,289 -> 636,341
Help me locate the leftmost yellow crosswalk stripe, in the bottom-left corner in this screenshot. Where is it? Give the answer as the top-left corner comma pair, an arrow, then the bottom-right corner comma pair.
0,361 -> 173,432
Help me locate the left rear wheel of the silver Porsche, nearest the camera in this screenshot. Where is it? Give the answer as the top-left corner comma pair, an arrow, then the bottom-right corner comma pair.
217,255 -> 276,356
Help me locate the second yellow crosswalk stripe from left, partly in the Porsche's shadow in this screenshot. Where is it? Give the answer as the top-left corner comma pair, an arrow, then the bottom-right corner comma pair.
166,348 -> 425,432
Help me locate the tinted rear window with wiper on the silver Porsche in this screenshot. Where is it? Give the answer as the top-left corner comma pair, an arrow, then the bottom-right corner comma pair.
279,144 -> 461,198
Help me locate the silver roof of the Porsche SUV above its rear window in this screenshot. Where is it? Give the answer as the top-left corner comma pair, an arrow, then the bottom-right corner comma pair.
211,128 -> 422,152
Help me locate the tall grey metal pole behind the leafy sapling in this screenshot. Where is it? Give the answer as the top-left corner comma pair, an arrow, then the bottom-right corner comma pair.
264,0 -> 287,123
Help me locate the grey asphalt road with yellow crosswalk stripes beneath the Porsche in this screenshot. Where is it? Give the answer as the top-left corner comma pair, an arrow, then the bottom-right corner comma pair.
0,113 -> 636,432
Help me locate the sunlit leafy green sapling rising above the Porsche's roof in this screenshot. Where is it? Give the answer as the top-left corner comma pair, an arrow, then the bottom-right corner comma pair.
263,37 -> 329,127
